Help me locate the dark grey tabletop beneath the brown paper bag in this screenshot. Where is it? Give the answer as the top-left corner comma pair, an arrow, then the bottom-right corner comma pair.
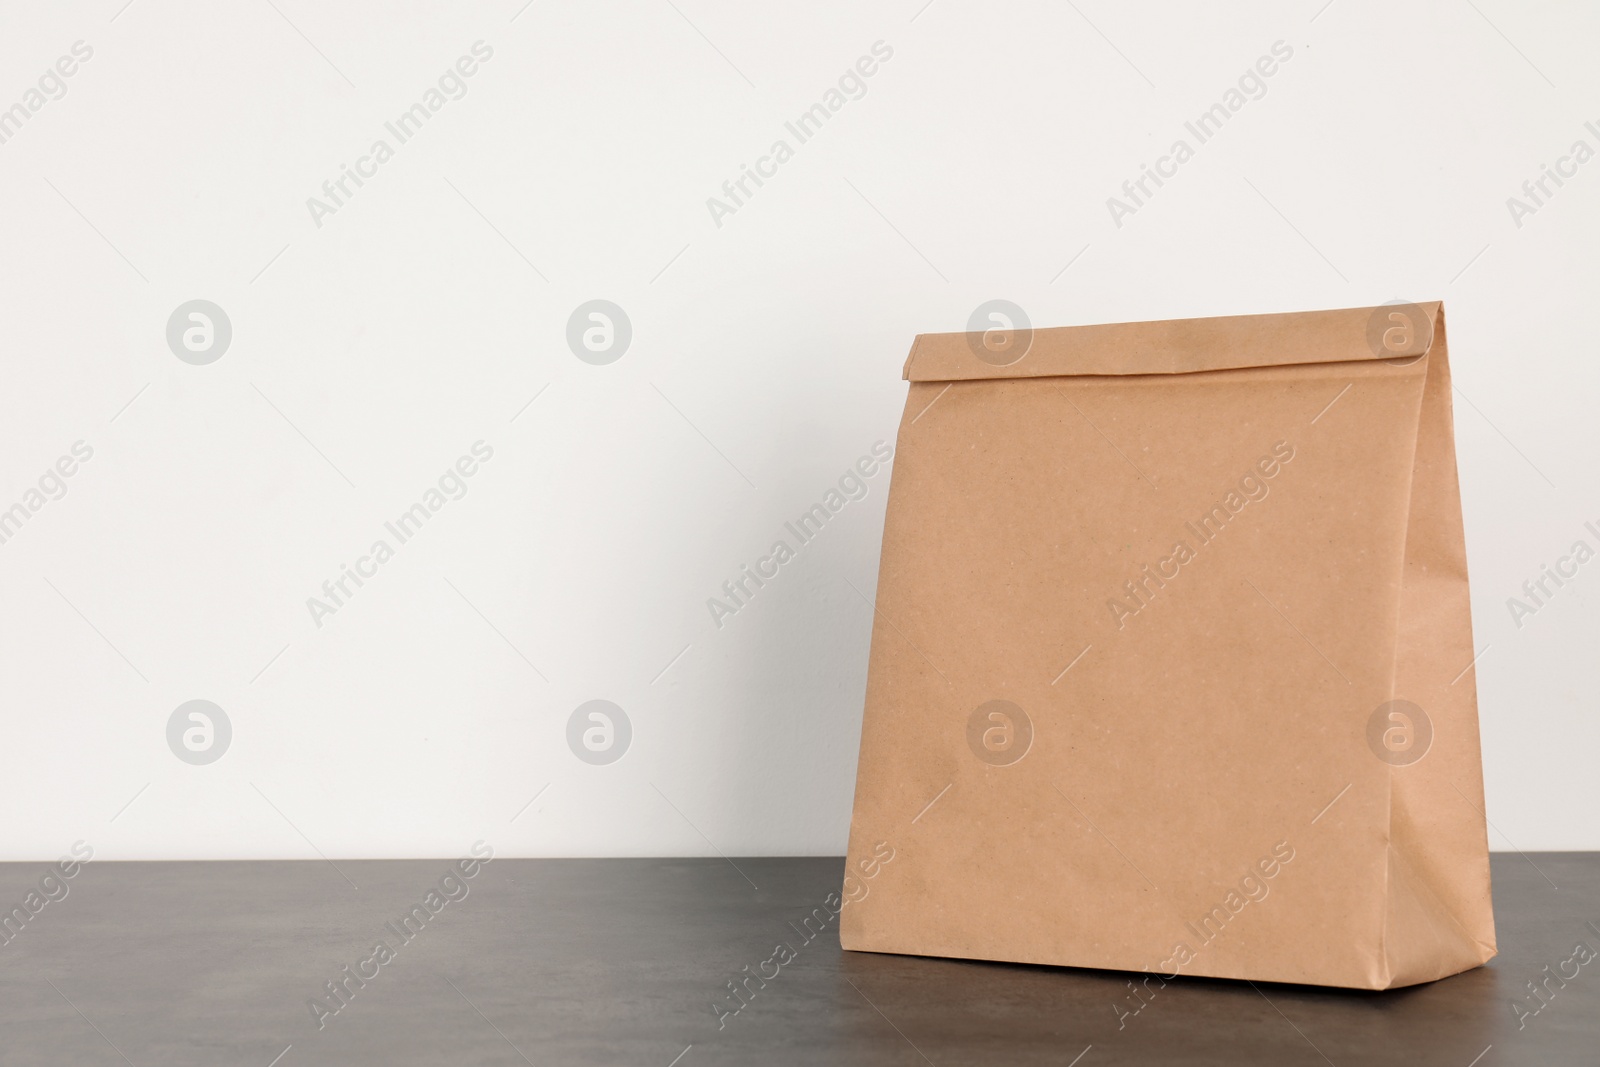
0,853 -> 1600,1067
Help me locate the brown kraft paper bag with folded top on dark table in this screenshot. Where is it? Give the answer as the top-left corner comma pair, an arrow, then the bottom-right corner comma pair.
840,304 -> 1494,989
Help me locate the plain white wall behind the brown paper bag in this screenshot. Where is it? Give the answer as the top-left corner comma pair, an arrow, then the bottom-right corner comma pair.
0,0 -> 1600,859
